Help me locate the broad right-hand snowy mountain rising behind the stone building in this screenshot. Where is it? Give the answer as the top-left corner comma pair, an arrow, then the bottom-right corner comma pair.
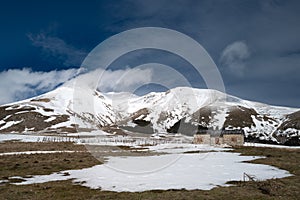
113,87 -> 298,141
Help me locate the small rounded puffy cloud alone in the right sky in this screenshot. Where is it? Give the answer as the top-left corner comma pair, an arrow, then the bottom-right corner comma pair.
220,41 -> 250,76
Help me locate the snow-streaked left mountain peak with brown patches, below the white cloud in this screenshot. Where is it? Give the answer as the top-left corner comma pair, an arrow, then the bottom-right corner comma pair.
0,86 -> 115,132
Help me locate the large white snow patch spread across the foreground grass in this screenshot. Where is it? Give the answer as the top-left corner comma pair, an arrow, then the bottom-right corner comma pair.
14,152 -> 291,192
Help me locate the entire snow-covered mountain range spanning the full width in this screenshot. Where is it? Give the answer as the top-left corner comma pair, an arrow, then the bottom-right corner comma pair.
0,84 -> 300,145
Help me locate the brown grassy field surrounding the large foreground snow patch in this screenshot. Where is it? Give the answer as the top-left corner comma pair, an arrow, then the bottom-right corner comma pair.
0,143 -> 300,200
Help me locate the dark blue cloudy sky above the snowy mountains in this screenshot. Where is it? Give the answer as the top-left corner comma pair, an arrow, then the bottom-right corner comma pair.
0,0 -> 300,107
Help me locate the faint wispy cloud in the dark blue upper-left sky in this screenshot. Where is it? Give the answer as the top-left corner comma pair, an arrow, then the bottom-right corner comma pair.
27,33 -> 87,66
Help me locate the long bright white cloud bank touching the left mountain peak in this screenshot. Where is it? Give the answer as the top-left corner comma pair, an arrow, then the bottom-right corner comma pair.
0,68 -> 153,105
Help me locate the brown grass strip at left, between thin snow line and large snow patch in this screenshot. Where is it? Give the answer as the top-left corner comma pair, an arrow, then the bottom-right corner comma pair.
0,152 -> 101,178
